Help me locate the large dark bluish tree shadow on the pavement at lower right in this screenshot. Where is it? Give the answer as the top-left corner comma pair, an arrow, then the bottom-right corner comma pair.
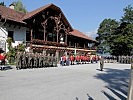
94,68 -> 130,100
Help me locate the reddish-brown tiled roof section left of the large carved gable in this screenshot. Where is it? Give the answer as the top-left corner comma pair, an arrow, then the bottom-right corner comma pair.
0,5 -> 25,23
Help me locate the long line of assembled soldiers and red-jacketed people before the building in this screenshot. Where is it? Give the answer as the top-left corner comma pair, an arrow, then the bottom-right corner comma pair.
0,52 -> 133,69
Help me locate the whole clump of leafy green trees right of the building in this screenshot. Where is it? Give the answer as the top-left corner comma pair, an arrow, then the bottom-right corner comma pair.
96,5 -> 133,56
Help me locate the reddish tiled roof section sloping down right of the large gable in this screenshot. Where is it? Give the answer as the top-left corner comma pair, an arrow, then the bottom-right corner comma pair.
70,29 -> 97,42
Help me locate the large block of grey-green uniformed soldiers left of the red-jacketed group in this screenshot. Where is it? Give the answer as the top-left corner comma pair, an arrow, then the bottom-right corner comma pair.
16,52 -> 57,69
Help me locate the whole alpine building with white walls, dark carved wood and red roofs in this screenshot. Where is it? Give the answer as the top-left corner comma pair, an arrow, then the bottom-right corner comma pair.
0,4 -> 97,60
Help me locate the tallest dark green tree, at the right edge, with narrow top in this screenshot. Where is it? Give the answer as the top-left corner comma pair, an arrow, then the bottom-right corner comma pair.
111,5 -> 133,55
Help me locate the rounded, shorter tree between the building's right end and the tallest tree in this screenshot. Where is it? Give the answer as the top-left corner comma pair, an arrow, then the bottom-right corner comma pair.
96,19 -> 119,53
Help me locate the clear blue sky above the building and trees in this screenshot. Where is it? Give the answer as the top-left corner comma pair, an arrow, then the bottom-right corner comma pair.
1,0 -> 133,37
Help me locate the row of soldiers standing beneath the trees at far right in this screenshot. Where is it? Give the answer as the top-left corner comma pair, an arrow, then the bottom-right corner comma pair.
118,56 -> 133,64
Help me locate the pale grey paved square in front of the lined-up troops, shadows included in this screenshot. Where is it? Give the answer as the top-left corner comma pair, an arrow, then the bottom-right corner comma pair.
0,63 -> 130,100
